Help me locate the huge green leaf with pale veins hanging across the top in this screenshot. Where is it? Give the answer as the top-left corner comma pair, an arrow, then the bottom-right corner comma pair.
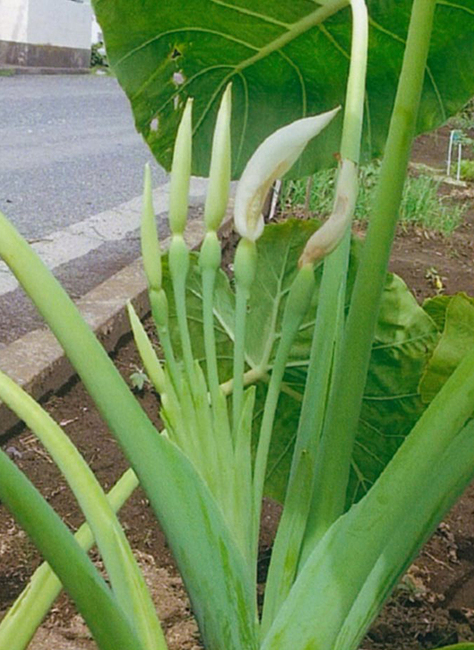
94,0 -> 474,176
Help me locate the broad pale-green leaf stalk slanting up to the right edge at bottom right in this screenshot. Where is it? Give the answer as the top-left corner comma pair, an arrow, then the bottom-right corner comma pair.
262,320 -> 474,650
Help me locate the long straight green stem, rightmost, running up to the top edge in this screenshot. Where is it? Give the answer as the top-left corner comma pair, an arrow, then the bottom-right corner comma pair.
305,0 -> 436,554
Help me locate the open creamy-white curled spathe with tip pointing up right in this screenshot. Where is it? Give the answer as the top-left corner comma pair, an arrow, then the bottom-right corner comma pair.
234,107 -> 340,241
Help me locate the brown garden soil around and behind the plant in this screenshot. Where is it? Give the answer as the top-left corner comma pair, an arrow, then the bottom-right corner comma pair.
0,123 -> 474,650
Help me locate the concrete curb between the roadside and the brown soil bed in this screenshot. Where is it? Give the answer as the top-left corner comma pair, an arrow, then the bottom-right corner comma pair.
0,209 -> 231,440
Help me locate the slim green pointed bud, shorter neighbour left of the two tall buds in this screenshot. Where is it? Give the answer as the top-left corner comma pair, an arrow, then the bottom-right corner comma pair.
141,163 -> 162,291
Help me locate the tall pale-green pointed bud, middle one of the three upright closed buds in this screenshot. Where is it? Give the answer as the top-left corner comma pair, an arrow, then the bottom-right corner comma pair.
169,98 -> 193,235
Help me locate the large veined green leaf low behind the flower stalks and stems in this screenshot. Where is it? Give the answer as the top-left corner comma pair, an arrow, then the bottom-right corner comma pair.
164,219 -> 439,503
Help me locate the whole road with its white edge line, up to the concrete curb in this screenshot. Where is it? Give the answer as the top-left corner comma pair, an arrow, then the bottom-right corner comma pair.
0,75 -> 206,347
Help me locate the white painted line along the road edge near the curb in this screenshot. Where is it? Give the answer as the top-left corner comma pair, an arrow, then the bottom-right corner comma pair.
0,178 -> 207,296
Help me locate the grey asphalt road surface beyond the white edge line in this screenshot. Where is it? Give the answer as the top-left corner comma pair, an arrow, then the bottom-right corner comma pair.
0,75 -> 166,239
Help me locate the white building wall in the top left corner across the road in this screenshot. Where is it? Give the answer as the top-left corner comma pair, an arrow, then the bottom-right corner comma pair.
27,0 -> 92,49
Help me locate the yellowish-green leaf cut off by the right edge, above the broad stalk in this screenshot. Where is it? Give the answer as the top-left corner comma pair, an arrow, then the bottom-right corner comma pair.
420,293 -> 474,403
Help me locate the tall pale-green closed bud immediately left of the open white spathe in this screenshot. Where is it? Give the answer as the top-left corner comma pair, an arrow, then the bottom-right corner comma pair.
204,84 -> 232,231
